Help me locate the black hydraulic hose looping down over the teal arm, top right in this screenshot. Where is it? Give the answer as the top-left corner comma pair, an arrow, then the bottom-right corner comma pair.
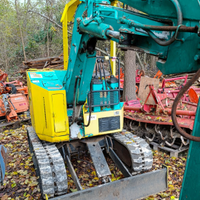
147,0 -> 183,46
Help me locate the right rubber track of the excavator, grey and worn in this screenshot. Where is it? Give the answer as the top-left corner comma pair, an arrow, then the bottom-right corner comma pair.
113,132 -> 153,173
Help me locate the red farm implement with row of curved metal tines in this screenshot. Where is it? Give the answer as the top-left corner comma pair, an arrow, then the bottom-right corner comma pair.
124,85 -> 197,149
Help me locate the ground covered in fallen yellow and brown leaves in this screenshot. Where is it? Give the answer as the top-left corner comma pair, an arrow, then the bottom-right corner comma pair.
0,125 -> 186,200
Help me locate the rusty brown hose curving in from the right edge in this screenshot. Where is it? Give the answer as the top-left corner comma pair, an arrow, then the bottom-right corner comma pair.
171,69 -> 200,142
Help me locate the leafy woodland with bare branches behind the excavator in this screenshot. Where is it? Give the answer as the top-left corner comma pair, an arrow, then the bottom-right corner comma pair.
0,0 -> 158,77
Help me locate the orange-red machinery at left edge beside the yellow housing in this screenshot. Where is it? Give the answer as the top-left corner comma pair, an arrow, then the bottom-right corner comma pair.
0,70 -> 29,121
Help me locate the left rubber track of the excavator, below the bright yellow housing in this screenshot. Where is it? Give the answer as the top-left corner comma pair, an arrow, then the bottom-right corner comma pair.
27,127 -> 68,199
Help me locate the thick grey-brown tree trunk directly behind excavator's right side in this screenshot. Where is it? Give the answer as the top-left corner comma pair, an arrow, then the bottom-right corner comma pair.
123,50 -> 136,101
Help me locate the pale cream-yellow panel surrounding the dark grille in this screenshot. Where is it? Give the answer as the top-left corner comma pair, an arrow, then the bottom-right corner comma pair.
83,108 -> 124,137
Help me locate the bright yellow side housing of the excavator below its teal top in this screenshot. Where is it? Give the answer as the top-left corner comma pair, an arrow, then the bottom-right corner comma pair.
28,77 -> 69,142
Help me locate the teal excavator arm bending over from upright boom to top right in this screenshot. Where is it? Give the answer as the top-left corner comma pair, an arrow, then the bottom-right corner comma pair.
64,0 -> 200,104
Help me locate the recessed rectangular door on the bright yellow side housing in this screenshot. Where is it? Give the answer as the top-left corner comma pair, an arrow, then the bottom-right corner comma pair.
52,94 -> 66,133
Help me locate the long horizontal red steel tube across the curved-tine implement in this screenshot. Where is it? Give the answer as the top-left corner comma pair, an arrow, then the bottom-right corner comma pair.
124,106 -> 196,116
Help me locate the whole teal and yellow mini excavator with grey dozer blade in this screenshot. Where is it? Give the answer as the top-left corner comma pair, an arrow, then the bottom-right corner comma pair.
27,0 -> 200,200
